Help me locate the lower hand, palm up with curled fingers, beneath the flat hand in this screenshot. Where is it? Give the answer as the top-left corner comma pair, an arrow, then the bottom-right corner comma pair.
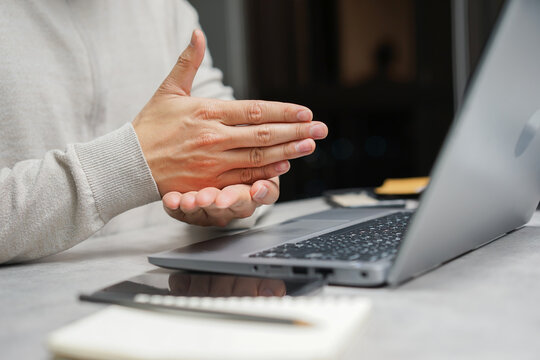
163,177 -> 279,226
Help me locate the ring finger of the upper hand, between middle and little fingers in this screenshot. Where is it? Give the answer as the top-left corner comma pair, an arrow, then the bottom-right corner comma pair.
227,139 -> 315,168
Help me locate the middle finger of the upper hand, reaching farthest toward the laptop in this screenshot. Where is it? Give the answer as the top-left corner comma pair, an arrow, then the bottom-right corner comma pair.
228,121 -> 328,149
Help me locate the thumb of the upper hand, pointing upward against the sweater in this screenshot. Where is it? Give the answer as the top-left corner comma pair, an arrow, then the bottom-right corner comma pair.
160,29 -> 206,96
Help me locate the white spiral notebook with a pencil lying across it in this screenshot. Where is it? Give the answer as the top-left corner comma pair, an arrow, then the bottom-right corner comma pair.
48,297 -> 371,359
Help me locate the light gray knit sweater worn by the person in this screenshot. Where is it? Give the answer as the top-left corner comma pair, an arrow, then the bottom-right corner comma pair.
0,0 -> 236,263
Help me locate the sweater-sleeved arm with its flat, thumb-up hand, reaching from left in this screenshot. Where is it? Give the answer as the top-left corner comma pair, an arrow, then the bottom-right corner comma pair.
0,32 -> 324,262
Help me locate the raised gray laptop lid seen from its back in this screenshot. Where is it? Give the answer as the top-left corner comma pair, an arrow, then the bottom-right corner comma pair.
388,0 -> 540,284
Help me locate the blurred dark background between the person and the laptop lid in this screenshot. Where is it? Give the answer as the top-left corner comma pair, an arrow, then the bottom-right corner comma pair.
190,0 -> 503,201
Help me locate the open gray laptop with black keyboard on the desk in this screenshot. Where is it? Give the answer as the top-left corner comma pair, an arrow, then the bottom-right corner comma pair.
149,0 -> 540,286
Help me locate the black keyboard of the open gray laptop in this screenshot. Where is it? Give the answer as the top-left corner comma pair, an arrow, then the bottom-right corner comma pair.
250,212 -> 412,261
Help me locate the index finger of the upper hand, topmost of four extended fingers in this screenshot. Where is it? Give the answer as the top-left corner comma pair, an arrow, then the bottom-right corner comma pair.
220,100 -> 313,125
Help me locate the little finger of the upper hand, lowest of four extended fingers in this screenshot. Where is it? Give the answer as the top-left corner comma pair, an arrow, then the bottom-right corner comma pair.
218,161 -> 291,187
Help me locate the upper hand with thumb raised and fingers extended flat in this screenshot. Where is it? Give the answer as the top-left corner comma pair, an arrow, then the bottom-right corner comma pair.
133,30 -> 328,196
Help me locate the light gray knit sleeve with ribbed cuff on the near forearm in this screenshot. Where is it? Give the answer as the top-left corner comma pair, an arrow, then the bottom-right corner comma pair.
0,124 -> 159,263
